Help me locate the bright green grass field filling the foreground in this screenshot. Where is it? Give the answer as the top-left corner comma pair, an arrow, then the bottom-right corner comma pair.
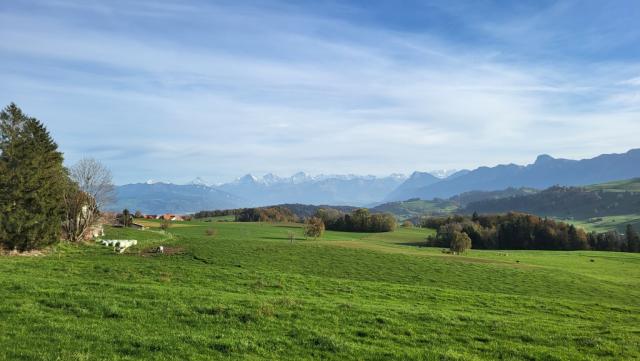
0,222 -> 640,360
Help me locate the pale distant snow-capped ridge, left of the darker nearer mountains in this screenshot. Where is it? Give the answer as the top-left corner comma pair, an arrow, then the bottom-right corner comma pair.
108,172 -> 406,214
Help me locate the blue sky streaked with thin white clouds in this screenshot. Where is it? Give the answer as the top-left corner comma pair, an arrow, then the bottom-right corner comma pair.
0,0 -> 640,184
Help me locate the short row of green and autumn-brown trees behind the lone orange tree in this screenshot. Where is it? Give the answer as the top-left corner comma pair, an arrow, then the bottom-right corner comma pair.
316,208 -> 397,232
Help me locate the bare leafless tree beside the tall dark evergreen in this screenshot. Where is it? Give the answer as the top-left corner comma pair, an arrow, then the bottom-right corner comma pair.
63,158 -> 115,242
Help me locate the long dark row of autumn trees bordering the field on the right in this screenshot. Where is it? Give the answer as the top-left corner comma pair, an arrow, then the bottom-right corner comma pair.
422,213 -> 640,252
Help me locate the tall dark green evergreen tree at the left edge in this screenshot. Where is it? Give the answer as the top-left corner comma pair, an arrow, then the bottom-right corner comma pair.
0,103 -> 67,251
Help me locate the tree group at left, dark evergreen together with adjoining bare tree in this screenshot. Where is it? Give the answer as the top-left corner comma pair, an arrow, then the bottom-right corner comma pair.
0,103 -> 113,251
